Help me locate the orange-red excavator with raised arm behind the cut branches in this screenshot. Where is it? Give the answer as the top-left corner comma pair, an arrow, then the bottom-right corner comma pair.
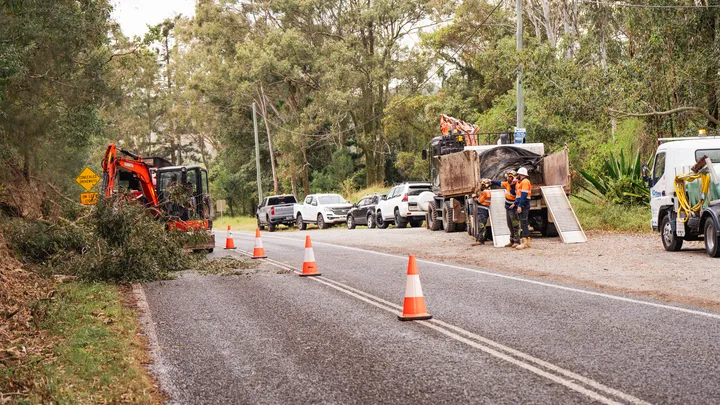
102,143 -> 215,252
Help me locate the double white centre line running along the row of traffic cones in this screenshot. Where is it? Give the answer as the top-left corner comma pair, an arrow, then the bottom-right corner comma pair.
219,245 -> 649,405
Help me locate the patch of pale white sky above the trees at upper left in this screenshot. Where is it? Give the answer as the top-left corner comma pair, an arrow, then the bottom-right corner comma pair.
112,0 -> 195,37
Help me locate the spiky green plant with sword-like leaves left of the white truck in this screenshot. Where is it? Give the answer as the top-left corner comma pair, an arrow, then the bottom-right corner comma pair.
578,151 -> 650,205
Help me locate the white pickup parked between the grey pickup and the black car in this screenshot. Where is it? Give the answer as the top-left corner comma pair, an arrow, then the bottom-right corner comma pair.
294,194 -> 352,230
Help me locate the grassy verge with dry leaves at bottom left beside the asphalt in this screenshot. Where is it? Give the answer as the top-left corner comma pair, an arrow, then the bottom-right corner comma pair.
0,282 -> 162,404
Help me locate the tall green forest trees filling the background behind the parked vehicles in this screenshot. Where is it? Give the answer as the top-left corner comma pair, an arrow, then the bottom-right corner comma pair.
0,0 -> 720,215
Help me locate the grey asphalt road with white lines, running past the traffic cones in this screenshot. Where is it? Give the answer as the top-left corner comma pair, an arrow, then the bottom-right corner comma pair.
143,230 -> 720,404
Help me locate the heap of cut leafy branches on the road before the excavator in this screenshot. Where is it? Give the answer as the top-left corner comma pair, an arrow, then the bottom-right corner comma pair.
6,198 -> 202,283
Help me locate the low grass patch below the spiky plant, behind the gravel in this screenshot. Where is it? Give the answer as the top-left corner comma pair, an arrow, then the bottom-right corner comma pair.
570,193 -> 652,233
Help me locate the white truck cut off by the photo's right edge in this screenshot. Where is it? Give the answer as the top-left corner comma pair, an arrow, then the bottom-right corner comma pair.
644,136 -> 720,257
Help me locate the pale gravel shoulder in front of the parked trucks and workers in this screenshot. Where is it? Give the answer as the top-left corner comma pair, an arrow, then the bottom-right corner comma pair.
298,228 -> 720,311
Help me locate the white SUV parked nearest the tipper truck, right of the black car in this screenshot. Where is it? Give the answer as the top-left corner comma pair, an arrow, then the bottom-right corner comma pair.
376,183 -> 432,229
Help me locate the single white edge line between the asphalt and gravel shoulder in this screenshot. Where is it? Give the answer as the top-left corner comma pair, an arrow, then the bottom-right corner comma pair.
219,230 -> 720,319
